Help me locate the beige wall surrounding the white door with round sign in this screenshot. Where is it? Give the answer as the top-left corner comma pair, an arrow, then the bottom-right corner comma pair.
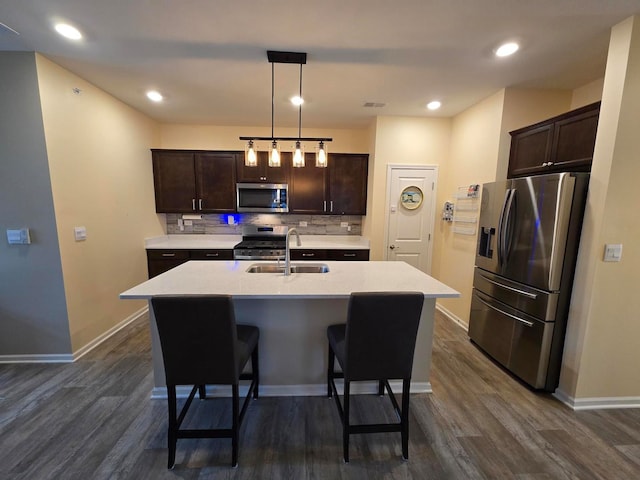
364,117 -> 451,264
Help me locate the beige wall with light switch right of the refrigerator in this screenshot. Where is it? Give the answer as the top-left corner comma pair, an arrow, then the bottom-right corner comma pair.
560,17 -> 640,402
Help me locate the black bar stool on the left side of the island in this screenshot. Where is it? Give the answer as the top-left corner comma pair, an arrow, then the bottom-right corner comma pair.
151,295 -> 260,469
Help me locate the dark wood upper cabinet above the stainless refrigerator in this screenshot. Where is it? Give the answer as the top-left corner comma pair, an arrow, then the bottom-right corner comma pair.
508,102 -> 600,178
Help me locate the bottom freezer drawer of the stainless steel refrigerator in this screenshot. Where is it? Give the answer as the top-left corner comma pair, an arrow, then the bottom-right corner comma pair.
469,290 -> 555,389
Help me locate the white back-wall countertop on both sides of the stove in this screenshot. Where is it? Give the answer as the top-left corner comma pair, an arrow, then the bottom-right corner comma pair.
144,232 -> 369,250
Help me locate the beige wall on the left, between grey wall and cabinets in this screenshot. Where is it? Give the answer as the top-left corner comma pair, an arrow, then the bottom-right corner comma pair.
36,55 -> 163,352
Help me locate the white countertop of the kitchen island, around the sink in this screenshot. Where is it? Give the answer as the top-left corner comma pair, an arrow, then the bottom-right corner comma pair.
120,260 -> 460,299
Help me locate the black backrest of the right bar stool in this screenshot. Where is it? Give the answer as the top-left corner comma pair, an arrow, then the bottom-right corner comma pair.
344,292 -> 424,380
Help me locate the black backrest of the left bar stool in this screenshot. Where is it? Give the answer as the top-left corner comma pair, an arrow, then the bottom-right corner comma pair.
151,295 -> 241,385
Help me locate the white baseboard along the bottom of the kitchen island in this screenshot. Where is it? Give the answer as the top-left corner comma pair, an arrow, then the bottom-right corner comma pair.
151,381 -> 433,399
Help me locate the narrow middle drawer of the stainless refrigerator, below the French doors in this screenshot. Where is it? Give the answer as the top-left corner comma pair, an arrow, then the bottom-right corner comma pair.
473,267 -> 559,322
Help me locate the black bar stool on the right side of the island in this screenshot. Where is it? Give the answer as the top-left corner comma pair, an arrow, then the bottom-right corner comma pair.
327,292 -> 424,463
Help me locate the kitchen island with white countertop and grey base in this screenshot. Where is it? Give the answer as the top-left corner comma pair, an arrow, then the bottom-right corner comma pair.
120,261 -> 459,396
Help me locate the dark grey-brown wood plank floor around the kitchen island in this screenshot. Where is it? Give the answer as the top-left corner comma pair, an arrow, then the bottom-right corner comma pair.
0,314 -> 640,480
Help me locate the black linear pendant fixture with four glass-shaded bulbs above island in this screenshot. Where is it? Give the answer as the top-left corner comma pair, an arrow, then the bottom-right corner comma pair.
240,50 -> 333,168
